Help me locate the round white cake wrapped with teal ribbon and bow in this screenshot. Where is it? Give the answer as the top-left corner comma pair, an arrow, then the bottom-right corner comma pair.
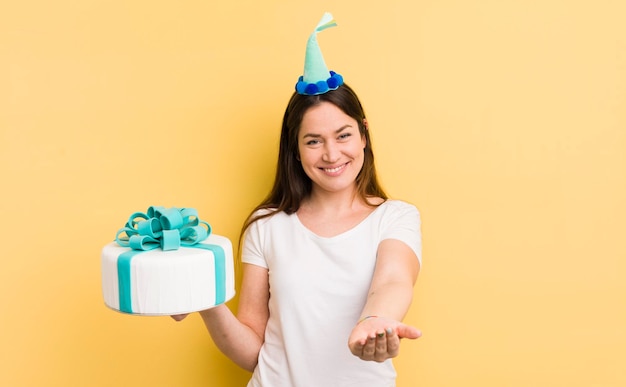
101,207 -> 235,316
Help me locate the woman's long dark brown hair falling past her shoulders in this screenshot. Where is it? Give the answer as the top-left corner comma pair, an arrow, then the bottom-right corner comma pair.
241,83 -> 387,235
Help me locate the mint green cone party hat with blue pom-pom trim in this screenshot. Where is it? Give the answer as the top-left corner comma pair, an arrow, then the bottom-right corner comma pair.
296,12 -> 343,95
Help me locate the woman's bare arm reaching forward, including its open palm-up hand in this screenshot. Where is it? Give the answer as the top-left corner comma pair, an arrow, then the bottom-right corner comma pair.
348,239 -> 421,362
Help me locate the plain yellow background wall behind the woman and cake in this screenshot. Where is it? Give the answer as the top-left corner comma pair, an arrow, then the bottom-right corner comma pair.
0,0 -> 626,387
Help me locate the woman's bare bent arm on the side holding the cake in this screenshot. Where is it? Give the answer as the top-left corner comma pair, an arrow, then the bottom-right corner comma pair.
173,263 -> 269,372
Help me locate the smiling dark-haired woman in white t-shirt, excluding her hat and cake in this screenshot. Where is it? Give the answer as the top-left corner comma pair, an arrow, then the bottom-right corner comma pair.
175,84 -> 421,387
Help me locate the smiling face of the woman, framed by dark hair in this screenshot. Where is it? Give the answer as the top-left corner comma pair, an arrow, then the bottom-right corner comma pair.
298,102 -> 365,196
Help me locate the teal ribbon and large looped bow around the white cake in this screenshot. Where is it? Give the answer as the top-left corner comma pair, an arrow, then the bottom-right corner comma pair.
115,206 -> 226,313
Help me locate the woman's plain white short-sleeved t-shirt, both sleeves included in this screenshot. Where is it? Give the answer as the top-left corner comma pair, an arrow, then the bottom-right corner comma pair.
242,200 -> 422,387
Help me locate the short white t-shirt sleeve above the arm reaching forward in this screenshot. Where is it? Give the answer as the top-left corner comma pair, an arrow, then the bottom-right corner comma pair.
380,202 -> 422,265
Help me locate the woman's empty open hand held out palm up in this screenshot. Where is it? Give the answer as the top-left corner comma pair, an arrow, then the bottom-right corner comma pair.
348,317 -> 422,362
